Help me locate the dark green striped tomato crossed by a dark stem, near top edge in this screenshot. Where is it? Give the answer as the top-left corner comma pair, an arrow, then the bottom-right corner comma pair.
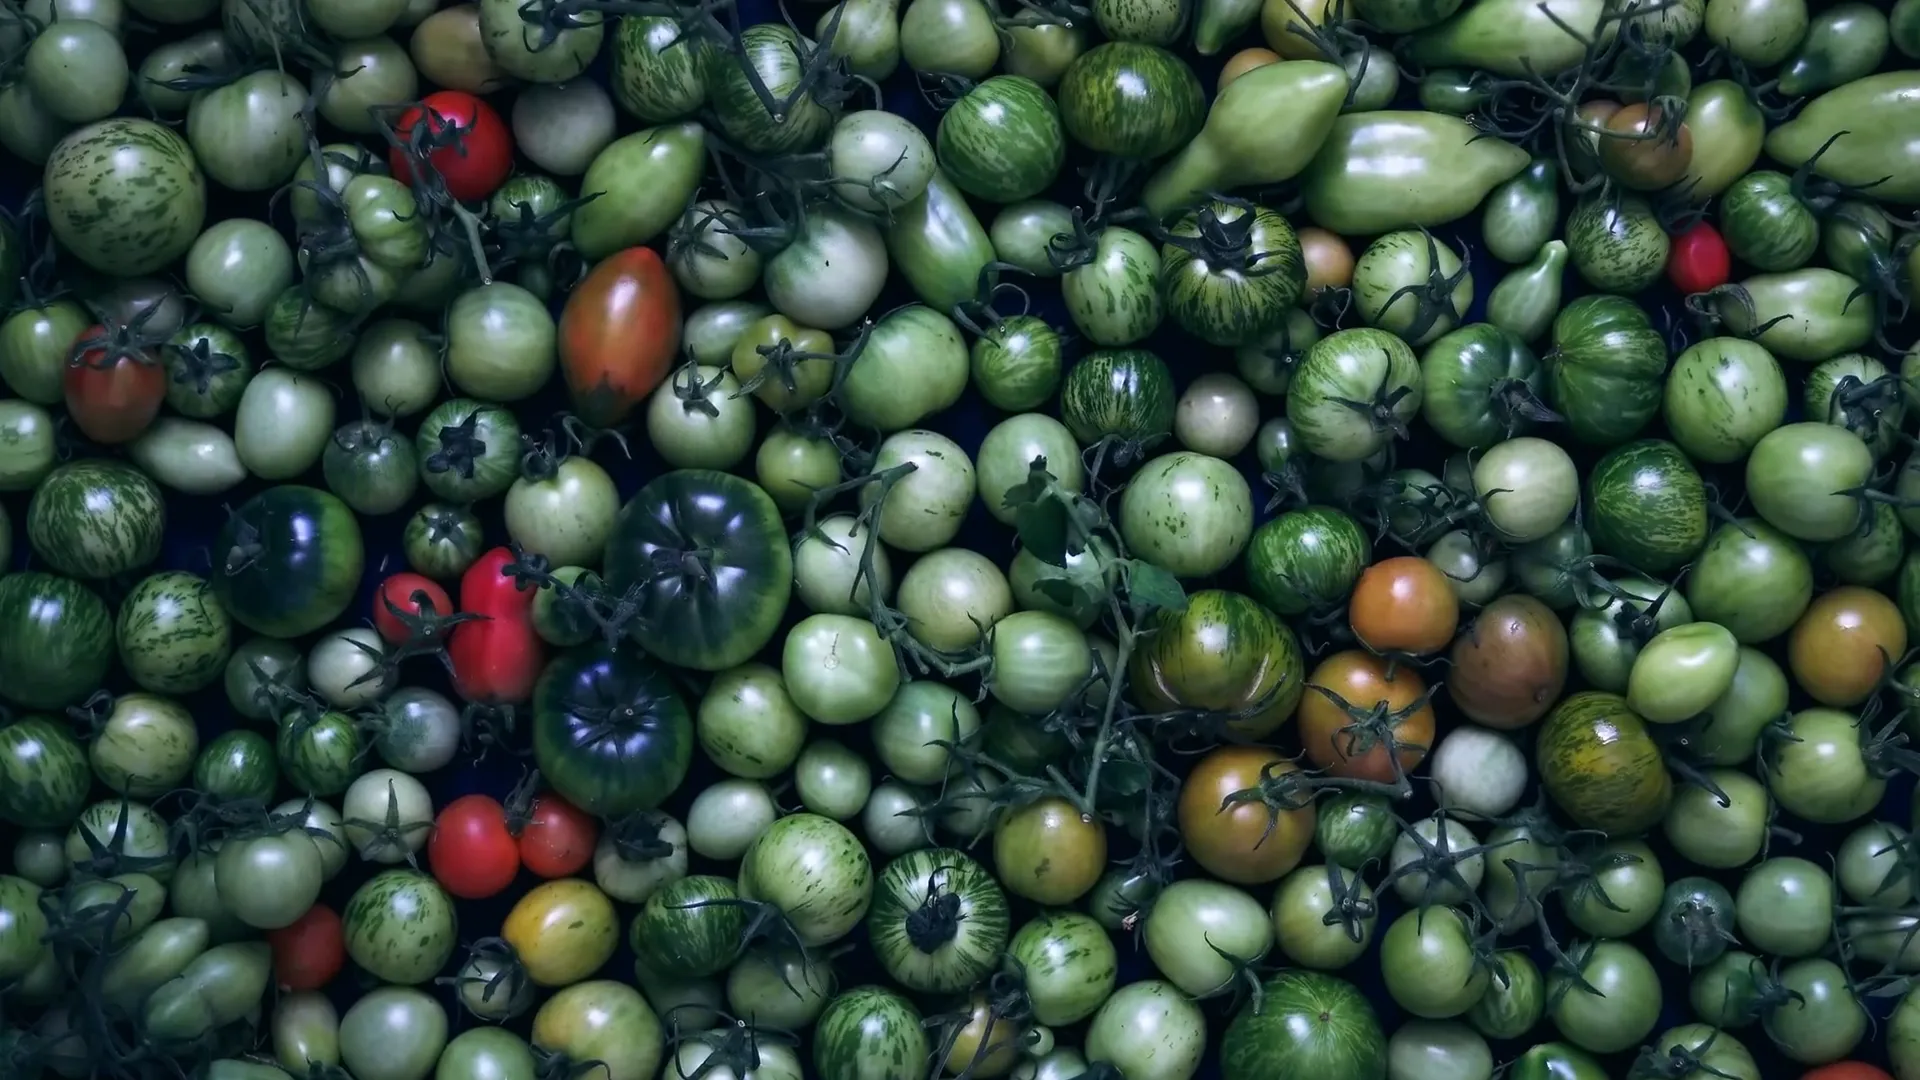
707,23 -> 835,154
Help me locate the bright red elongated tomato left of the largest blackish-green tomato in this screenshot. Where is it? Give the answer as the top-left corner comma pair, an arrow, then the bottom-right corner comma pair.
447,548 -> 547,705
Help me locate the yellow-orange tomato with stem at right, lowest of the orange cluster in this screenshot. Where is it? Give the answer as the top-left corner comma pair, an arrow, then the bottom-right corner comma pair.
1175,746 -> 1317,886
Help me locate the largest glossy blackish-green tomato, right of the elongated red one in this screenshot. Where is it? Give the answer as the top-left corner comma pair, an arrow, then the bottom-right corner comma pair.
605,469 -> 793,671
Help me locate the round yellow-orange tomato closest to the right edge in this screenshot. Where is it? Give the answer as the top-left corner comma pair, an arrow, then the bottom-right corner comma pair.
1788,584 -> 1907,709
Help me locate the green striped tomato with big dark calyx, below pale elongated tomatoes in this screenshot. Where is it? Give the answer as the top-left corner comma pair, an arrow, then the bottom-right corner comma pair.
1160,202 -> 1308,346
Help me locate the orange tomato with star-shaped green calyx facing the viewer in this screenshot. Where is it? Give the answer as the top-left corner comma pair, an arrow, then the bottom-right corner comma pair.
1298,650 -> 1434,784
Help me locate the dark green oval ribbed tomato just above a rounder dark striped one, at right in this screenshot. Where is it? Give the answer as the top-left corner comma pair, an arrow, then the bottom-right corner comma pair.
1548,296 -> 1667,446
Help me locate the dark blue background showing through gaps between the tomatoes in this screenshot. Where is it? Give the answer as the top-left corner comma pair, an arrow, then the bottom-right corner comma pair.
0,0 -> 1910,1080
